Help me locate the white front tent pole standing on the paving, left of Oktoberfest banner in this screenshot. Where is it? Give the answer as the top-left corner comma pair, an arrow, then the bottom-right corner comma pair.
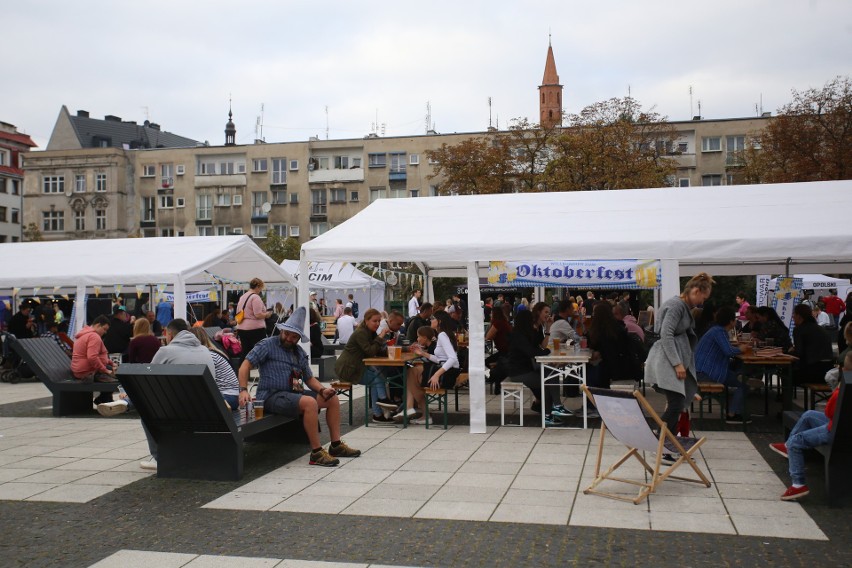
467,262 -> 486,434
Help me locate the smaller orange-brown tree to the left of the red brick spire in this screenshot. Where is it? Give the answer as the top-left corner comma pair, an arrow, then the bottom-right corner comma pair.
426,136 -> 510,195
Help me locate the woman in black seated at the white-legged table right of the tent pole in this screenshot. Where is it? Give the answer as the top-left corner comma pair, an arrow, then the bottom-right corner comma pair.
507,310 -> 571,426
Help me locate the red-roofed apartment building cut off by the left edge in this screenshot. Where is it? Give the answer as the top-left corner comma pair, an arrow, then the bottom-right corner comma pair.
0,122 -> 36,243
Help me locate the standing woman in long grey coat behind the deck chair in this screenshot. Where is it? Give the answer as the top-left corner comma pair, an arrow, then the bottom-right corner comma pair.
645,272 -> 716,432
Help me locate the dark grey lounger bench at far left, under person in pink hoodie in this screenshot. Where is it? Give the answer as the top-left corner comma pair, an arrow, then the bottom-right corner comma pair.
12,337 -> 118,416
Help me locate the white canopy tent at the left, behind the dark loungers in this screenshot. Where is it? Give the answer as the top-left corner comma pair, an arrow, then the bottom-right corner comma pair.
0,235 -> 296,332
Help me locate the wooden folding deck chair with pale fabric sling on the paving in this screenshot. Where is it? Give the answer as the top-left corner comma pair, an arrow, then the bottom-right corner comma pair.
582,385 -> 710,505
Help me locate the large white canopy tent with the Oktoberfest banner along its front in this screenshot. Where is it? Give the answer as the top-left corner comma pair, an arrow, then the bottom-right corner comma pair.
299,181 -> 852,433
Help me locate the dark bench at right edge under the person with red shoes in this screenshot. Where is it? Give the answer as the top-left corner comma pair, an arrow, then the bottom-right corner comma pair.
784,371 -> 852,507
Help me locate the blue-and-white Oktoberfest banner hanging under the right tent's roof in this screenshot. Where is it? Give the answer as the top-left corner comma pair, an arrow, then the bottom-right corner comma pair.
488,260 -> 660,290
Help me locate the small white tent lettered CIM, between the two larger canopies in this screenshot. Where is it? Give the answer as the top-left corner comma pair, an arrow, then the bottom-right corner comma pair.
269,260 -> 385,314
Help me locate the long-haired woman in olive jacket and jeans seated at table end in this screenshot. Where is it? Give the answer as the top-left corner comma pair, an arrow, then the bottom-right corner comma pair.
334,308 -> 393,422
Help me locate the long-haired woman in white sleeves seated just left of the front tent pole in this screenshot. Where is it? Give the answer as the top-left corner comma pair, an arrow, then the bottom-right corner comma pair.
393,312 -> 461,424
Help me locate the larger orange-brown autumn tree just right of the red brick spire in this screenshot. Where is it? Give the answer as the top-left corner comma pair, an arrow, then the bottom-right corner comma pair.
546,97 -> 677,191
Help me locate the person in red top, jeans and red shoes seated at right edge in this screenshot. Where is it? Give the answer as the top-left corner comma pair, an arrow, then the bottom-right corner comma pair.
769,352 -> 852,501
